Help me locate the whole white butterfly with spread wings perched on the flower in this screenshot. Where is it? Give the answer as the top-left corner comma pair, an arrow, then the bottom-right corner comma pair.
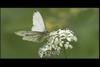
15,11 -> 48,43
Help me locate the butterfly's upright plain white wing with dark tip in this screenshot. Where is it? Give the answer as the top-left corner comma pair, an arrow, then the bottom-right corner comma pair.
32,11 -> 45,32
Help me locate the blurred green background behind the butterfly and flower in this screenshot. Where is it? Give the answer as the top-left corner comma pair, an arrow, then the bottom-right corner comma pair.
1,8 -> 99,58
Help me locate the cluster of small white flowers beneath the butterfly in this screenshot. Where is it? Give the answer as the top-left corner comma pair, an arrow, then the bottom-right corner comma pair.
38,29 -> 77,58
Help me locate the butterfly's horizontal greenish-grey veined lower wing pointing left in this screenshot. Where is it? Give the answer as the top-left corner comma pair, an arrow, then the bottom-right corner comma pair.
15,31 -> 47,43
